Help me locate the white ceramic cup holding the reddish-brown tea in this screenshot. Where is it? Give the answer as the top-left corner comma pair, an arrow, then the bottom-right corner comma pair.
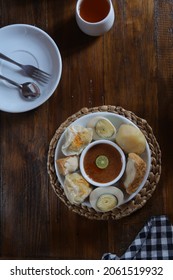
76,0 -> 115,36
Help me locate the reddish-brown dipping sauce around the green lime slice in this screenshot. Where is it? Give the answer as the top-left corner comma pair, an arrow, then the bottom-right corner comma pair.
84,143 -> 122,183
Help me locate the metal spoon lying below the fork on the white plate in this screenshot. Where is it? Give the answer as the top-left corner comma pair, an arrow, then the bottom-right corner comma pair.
0,75 -> 40,100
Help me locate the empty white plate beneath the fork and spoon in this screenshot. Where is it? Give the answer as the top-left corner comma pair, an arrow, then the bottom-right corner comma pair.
0,24 -> 62,113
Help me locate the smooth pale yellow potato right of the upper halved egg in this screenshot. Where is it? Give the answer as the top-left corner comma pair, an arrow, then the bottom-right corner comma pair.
116,124 -> 146,155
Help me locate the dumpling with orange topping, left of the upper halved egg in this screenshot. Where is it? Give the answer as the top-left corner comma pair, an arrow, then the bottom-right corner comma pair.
62,125 -> 93,156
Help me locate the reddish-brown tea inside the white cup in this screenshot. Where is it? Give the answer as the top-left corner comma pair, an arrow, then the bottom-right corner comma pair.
79,0 -> 110,22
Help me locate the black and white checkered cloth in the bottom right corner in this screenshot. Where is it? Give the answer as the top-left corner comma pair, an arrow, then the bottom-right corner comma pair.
102,215 -> 173,260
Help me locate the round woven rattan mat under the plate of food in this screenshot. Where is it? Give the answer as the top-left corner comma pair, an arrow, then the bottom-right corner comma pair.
47,105 -> 161,220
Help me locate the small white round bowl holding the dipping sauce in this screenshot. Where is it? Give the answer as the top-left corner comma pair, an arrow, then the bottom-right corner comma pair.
79,140 -> 126,187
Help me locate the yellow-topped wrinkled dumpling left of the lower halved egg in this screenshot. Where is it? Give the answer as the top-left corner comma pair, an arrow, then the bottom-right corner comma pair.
64,172 -> 92,205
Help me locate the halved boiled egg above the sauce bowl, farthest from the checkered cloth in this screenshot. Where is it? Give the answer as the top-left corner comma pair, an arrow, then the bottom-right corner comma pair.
87,116 -> 116,140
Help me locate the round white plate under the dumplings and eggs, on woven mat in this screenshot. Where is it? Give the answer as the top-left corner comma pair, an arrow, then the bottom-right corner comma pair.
54,112 -> 151,206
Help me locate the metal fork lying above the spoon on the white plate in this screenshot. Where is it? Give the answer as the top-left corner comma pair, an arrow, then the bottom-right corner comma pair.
0,53 -> 51,83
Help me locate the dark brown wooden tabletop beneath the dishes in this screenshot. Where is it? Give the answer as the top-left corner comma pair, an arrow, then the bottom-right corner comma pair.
0,0 -> 173,259
